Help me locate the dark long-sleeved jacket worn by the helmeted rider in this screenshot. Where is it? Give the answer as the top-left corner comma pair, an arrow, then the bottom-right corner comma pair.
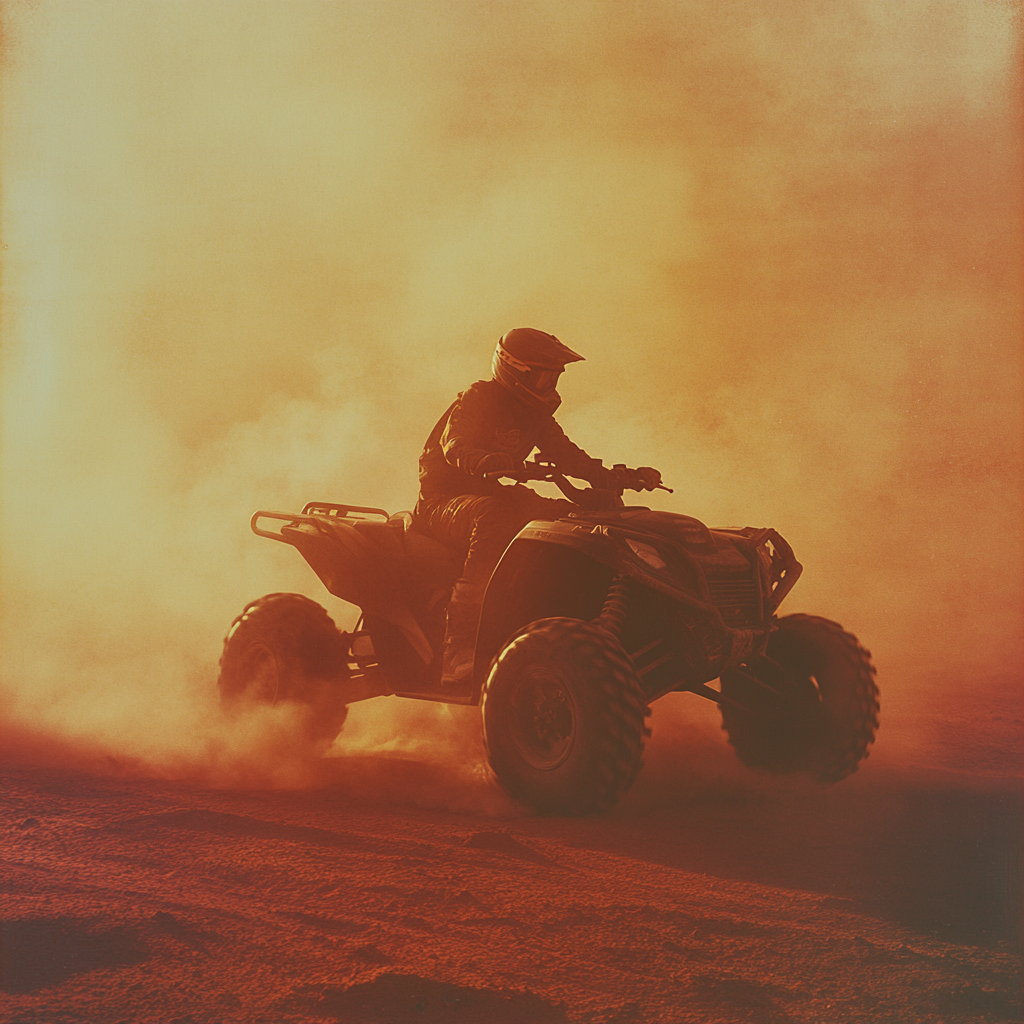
420,380 -> 602,502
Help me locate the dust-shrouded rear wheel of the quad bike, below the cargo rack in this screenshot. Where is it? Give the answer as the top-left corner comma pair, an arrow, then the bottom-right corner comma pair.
217,594 -> 348,740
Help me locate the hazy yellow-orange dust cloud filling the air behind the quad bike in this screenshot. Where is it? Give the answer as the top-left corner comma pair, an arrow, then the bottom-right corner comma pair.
2,0 -> 1024,784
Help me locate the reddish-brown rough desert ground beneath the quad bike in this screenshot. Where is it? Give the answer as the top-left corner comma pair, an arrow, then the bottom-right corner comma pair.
2,677 -> 1024,1024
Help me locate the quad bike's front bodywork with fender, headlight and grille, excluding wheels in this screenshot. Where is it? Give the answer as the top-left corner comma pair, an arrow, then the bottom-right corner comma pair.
476,508 -> 801,700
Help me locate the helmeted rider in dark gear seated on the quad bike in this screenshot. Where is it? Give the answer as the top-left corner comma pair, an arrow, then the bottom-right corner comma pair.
416,328 -> 662,687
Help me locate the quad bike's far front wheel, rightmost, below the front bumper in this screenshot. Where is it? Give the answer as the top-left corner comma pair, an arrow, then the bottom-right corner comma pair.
721,615 -> 879,782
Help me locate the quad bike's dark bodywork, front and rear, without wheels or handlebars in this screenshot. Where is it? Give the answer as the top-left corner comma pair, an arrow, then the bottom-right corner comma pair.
245,503 -> 801,703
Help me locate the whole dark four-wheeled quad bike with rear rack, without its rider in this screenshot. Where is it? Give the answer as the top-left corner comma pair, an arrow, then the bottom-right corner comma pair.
218,462 -> 879,814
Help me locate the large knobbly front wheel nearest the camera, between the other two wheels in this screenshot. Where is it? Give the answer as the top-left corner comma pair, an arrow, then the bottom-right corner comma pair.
482,618 -> 649,814
